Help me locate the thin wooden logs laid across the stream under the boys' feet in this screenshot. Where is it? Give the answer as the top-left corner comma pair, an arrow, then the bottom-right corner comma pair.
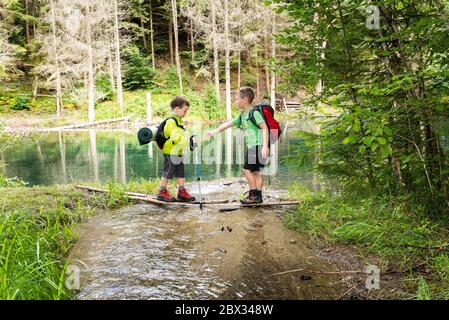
75,186 -> 299,208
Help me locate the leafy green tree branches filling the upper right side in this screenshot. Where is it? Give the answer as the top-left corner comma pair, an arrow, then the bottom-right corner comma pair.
272,0 -> 449,216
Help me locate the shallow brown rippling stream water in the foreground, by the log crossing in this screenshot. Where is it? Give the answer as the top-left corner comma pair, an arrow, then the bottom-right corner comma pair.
70,180 -> 344,299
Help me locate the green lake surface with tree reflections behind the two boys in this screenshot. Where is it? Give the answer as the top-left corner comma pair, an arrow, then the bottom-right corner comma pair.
0,121 -> 316,185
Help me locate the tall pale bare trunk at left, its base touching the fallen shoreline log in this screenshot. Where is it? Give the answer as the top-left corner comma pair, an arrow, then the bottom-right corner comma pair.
86,2 -> 95,122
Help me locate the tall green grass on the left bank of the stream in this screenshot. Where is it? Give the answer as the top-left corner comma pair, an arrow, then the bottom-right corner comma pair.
0,180 -> 158,299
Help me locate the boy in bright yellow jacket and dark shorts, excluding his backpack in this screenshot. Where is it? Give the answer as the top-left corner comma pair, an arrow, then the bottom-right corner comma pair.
157,96 -> 195,202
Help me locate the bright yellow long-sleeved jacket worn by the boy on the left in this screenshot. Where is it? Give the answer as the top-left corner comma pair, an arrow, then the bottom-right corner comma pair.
162,114 -> 189,155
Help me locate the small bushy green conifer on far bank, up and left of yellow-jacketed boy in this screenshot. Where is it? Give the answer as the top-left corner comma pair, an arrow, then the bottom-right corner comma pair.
123,45 -> 154,90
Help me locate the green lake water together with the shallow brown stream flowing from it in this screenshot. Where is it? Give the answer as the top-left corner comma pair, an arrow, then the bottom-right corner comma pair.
0,120 -> 345,299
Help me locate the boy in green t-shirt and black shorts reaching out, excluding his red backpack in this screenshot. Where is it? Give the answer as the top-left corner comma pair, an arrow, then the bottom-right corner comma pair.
205,87 -> 270,204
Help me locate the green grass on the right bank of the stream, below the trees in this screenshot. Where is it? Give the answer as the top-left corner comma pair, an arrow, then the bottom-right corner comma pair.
284,184 -> 449,299
